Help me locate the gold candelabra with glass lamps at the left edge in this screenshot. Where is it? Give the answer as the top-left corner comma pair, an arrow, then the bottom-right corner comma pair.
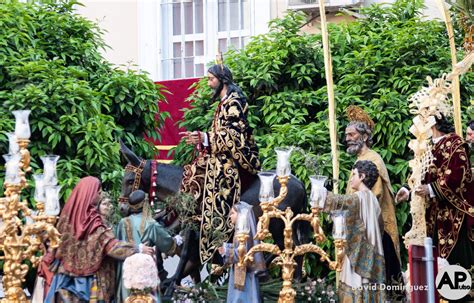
0,110 -> 60,303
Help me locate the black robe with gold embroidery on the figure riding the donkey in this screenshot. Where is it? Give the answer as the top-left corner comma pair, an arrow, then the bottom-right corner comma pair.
181,92 -> 260,263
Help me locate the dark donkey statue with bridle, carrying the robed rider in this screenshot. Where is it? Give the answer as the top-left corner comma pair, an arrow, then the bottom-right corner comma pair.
119,141 -> 310,296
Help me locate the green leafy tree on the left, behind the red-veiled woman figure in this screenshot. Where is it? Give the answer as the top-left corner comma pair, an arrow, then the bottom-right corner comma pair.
0,1 -> 168,198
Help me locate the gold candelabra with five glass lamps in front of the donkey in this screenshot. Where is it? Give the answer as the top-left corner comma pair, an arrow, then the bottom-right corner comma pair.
236,148 -> 346,303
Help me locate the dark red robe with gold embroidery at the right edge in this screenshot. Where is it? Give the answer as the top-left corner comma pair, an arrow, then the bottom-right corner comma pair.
424,134 -> 474,267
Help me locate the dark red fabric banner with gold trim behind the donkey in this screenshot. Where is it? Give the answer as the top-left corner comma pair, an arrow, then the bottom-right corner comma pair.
147,78 -> 199,162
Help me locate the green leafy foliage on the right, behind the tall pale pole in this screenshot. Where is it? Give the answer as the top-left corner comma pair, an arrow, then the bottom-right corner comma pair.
176,0 -> 474,274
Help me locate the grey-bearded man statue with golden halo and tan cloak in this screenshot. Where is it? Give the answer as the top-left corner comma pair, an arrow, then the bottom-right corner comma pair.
345,106 -> 401,283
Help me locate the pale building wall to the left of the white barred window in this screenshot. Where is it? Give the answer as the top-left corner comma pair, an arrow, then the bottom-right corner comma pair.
76,0 -> 139,65
